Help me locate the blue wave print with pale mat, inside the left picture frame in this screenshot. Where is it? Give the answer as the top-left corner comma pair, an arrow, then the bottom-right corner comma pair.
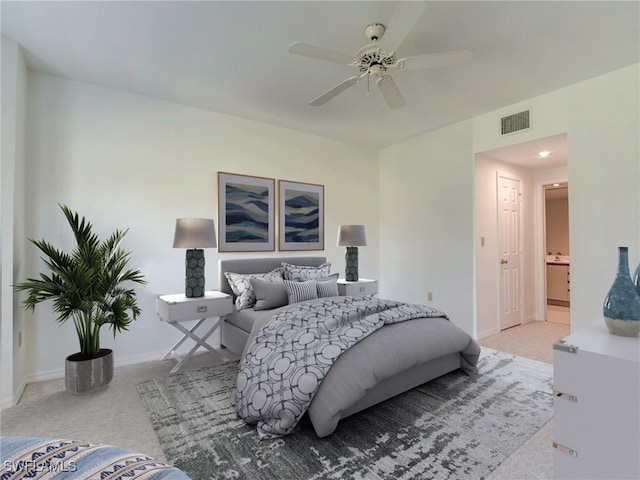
225,183 -> 269,243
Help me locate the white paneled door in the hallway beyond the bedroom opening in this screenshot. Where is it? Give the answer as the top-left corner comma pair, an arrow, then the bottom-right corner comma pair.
497,173 -> 522,330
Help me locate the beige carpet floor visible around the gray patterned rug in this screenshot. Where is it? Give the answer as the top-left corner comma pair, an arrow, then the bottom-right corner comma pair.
0,322 -> 569,480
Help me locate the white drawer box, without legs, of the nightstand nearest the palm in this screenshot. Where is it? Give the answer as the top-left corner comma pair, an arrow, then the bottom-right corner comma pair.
158,291 -> 233,322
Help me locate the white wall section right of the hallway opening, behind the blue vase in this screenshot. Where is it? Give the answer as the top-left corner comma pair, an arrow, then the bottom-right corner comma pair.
568,65 -> 640,331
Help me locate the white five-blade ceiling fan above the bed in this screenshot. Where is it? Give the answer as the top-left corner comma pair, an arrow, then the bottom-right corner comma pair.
289,2 -> 473,110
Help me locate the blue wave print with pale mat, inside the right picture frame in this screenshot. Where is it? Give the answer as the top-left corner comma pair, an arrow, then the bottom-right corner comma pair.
284,189 -> 320,243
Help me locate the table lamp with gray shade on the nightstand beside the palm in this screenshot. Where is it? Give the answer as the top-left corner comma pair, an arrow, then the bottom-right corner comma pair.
173,218 -> 216,298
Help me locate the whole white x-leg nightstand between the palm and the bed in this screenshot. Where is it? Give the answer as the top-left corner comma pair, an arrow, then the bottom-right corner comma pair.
157,290 -> 233,373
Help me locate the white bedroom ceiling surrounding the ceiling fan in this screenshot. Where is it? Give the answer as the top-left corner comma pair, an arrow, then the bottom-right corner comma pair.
0,0 -> 640,163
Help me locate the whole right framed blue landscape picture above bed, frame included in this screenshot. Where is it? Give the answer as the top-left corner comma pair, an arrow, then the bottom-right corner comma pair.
278,180 -> 324,251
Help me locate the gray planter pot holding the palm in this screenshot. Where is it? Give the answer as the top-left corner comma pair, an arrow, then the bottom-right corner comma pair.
64,348 -> 113,393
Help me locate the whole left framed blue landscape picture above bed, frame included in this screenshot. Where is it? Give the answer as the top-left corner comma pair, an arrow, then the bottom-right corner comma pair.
218,172 -> 276,252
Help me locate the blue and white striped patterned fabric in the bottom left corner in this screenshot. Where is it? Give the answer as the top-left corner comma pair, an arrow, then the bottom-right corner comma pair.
0,437 -> 189,480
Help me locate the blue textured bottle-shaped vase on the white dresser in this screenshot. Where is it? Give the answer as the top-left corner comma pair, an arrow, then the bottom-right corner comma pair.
602,247 -> 640,337
